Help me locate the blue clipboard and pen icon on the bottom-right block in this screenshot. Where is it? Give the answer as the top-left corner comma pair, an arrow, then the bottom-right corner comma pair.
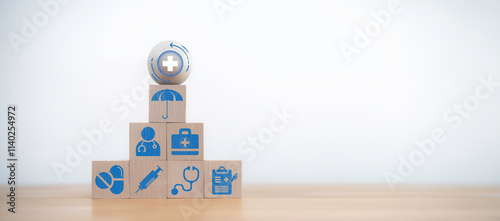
212,167 -> 238,195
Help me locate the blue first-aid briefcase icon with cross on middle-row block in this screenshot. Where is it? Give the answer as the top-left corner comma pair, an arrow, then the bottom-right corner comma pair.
171,128 -> 200,155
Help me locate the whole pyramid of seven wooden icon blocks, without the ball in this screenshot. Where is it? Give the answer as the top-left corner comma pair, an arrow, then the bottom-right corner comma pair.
92,85 -> 242,198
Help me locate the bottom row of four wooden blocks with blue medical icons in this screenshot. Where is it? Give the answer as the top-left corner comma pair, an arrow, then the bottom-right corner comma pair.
92,160 -> 242,199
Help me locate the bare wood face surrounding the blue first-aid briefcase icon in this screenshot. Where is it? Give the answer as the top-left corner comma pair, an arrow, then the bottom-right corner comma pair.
167,123 -> 205,161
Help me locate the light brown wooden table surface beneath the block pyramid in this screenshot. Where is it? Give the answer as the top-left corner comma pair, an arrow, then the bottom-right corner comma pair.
0,185 -> 500,221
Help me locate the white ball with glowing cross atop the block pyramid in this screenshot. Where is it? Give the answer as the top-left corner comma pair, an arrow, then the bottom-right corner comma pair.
148,41 -> 193,84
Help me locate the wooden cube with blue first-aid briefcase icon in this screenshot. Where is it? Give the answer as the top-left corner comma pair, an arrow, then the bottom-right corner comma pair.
167,123 -> 204,161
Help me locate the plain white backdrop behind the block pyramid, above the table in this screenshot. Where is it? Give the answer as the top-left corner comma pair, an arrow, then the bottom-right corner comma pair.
0,0 -> 500,185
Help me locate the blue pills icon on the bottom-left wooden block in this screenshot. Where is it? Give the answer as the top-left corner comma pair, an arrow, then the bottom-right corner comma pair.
95,165 -> 124,194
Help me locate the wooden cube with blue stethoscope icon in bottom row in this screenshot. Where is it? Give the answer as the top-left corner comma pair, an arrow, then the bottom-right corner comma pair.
167,161 -> 204,198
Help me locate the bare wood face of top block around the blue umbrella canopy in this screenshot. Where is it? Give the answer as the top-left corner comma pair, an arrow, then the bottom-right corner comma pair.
149,85 -> 187,123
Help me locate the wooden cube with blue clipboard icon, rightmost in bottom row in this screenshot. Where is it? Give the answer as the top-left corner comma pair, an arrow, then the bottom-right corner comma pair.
205,160 -> 243,198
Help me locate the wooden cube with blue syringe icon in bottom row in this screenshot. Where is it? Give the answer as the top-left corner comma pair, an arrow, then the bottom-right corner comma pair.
130,160 -> 168,199
